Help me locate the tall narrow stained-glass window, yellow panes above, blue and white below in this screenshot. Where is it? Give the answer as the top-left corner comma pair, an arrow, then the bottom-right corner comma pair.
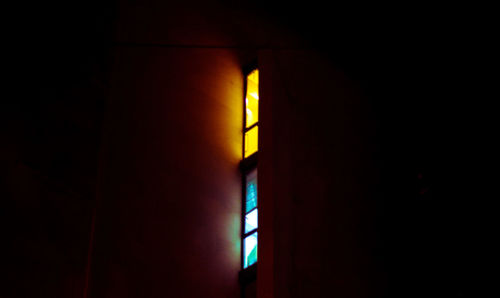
241,69 -> 259,269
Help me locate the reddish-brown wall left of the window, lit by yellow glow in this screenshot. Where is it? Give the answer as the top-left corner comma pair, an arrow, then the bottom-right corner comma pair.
91,47 -> 243,297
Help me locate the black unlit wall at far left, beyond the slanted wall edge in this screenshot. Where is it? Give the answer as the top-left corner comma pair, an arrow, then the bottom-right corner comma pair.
0,1 -> 112,297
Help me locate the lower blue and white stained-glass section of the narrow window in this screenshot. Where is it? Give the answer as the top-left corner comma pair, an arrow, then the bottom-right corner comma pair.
243,169 -> 258,268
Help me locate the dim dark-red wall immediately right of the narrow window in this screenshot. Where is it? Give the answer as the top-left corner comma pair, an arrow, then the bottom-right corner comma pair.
258,50 -> 383,298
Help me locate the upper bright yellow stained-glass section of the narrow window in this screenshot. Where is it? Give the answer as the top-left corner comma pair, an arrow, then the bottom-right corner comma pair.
244,69 -> 259,157
